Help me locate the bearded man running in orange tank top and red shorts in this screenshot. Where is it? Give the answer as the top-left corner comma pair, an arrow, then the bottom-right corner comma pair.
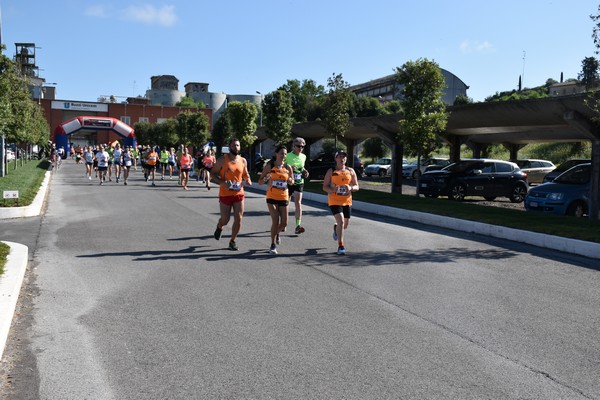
210,138 -> 252,251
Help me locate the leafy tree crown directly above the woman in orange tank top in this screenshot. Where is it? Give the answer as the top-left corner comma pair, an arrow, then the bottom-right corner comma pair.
262,90 -> 294,144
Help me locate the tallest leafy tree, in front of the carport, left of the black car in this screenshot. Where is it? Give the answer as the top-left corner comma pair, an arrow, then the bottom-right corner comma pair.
396,59 -> 448,196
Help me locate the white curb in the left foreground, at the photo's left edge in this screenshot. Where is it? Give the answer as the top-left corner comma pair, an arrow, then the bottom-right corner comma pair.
0,241 -> 29,360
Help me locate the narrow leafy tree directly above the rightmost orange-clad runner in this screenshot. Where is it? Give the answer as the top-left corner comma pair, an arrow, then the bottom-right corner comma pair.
325,73 -> 352,142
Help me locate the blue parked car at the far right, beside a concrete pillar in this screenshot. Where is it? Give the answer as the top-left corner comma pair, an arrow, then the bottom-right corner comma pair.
525,163 -> 592,217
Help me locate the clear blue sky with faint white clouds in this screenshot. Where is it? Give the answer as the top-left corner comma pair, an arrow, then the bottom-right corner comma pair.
0,0 -> 599,101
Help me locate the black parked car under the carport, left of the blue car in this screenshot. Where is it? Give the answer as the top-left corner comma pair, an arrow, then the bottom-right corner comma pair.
419,159 -> 529,203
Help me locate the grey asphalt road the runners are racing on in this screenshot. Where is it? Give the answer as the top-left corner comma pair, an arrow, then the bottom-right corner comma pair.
0,162 -> 600,399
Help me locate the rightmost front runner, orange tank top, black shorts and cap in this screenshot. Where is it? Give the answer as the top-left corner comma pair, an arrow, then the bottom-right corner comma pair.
323,150 -> 359,255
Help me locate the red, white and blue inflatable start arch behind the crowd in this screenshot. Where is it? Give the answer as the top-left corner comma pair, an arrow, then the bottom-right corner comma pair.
54,116 -> 136,154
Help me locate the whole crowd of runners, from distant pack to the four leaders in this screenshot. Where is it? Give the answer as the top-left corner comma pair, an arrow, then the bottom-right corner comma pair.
52,137 -> 359,255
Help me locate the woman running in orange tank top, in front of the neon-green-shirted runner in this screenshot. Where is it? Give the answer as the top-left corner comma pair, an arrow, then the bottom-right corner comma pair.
258,144 -> 294,254
